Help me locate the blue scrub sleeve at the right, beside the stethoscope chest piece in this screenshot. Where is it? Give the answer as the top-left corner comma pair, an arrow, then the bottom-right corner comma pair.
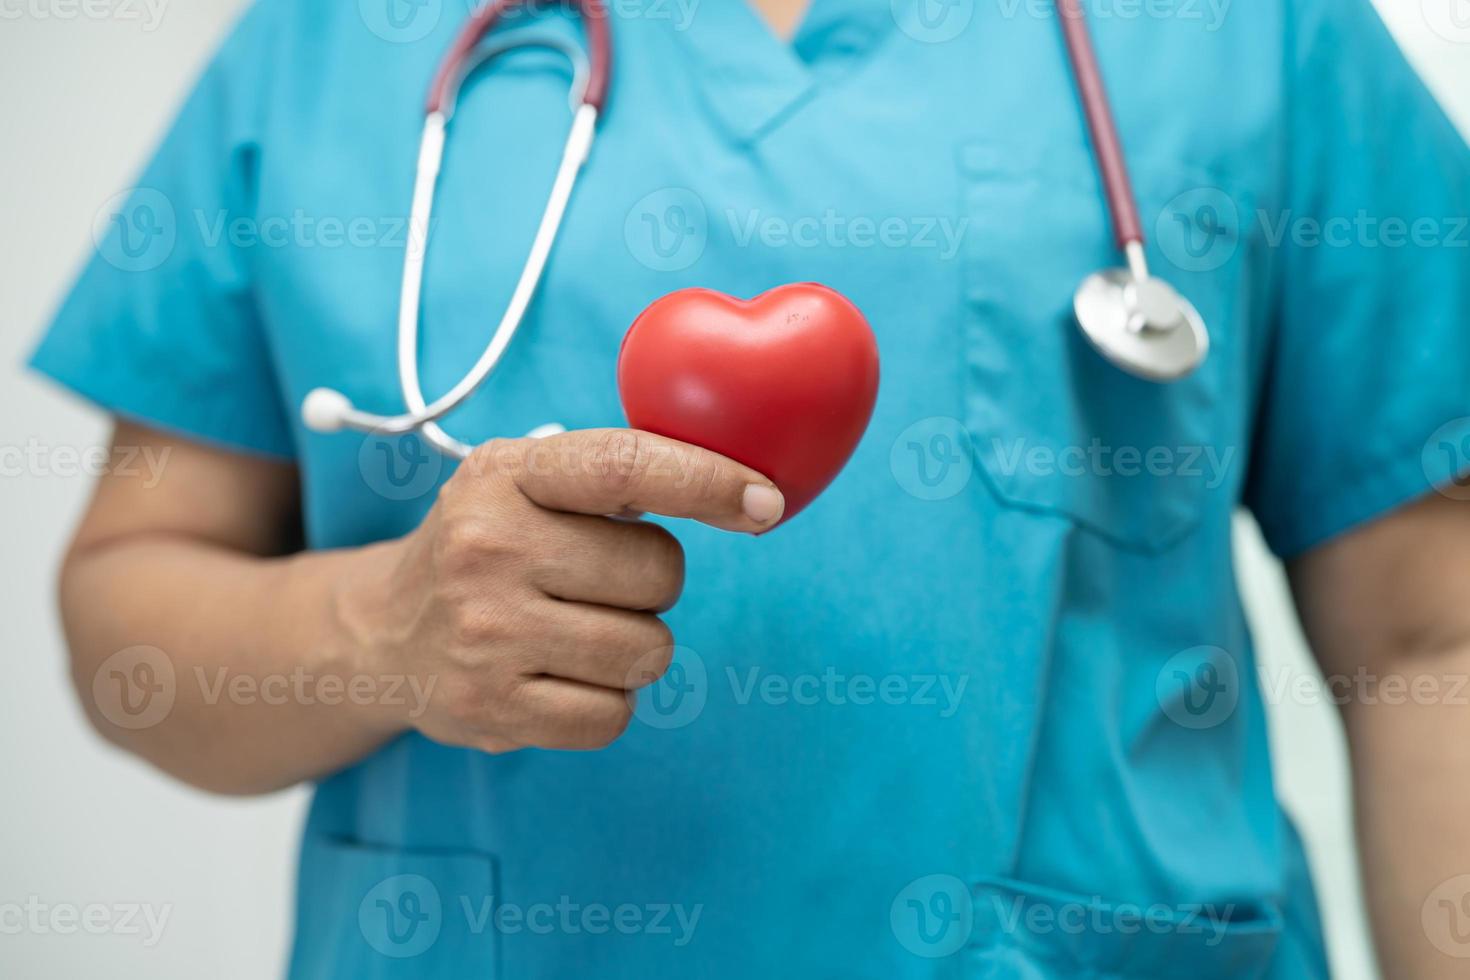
1245,0 -> 1470,557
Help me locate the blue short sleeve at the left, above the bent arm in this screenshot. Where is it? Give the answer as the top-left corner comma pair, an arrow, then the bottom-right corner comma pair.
31,6 -> 294,457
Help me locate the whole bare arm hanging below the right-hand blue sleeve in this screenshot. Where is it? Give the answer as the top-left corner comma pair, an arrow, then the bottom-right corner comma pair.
1288,495 -> 1470,979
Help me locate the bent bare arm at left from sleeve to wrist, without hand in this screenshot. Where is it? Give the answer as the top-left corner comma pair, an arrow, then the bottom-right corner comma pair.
60,423 -> 404,793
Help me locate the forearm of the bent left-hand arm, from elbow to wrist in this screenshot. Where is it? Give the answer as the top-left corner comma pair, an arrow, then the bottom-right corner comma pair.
62,535 -> 408,793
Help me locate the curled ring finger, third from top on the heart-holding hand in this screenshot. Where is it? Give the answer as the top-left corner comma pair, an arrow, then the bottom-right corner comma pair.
522,599 -> 673,691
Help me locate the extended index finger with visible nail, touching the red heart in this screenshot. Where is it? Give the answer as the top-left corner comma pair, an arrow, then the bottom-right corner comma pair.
499,429 -> 785,533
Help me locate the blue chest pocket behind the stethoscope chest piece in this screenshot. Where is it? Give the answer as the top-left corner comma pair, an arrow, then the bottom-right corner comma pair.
958,143 -> 1248,552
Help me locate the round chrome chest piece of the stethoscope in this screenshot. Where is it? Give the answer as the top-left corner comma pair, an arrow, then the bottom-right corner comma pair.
1073,269 -> 1210,381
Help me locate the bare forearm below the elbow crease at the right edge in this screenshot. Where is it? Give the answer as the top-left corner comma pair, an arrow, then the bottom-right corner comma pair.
1344,646 -> 1470,980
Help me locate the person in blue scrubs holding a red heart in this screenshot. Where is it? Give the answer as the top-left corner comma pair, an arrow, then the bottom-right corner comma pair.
34,0 -> 1470,980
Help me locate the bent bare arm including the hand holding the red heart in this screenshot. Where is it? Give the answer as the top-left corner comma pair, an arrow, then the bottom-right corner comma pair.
60,423 -> 781,793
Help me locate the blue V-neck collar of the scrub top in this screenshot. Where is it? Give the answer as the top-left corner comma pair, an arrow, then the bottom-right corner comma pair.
681,0 -> 891,143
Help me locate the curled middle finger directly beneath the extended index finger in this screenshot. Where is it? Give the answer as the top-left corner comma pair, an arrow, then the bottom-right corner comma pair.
531,514 -> 684,613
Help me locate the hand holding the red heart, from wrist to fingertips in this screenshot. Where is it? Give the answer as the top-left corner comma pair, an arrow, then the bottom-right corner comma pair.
338,429 -> 784,752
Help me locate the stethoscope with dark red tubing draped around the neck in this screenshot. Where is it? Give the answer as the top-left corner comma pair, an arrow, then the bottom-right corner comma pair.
301,0 -> 1210,458
